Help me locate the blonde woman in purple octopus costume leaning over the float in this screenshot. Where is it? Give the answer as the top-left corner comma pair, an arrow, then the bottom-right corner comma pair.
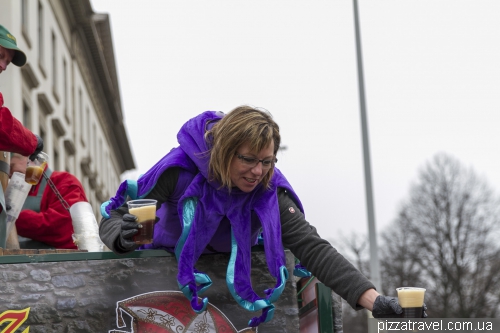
100,106 -> 422,326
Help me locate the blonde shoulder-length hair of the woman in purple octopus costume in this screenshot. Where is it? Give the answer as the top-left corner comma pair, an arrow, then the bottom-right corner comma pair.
205,105 -> 281,190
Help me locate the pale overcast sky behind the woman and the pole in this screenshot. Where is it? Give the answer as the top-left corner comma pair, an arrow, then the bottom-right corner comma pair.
91,0 -> 500,243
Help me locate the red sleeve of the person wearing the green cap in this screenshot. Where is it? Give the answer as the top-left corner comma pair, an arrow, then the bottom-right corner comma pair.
0,93 -> 37,156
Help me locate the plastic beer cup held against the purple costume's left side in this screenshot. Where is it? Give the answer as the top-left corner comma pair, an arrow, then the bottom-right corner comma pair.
127,199 -> 156,245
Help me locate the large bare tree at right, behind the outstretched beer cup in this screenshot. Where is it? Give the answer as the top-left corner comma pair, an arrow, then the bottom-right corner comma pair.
381,154 -> 500,318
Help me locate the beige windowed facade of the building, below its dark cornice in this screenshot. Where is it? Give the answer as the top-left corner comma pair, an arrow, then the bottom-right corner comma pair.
0,0 -> 133,218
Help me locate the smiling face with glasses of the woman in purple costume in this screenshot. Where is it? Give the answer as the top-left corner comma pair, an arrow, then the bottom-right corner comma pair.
230,141 -> 275,192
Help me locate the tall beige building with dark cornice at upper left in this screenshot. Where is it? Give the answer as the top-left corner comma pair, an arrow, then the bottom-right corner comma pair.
0,0 -> 135,218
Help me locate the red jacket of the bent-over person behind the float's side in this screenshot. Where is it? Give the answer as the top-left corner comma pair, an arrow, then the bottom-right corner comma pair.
16,171 -> 87,249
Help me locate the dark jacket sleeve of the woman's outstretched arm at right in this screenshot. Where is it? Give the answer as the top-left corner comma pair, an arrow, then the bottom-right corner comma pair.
278,189 -> 375,309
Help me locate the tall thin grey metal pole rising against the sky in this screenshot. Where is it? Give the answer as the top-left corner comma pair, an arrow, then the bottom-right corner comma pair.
353,0 -> 381,291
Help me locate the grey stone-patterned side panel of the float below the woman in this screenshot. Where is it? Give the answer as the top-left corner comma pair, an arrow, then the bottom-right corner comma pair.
0,251 -> 299,333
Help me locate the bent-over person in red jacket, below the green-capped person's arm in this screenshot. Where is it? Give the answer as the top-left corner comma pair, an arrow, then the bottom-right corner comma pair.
10,154 -> 87,249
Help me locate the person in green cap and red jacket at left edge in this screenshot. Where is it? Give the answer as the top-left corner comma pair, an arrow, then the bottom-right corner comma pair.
0,25 -> 43,247
